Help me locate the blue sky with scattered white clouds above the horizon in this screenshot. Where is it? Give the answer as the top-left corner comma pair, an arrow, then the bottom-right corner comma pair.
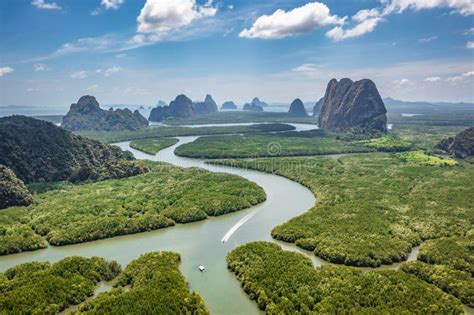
0,0 -> 474,106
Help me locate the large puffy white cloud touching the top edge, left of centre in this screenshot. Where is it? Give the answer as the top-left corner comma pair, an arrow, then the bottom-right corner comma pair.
136,0 -> 217,39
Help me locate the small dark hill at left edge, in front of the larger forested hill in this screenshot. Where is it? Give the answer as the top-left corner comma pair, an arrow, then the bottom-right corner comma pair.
0,165 -> 33,209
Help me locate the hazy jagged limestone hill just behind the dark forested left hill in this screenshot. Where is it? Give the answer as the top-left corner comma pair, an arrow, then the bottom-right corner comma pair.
61,95 -> 148,131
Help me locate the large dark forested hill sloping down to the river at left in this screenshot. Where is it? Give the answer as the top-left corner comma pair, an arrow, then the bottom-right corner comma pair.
0,116 -> 144,183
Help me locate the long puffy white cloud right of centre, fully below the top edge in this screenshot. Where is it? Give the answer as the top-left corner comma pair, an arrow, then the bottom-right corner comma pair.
239,2 -> 345,39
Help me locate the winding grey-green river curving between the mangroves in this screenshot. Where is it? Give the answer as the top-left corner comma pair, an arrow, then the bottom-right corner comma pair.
0,124 -> 426,314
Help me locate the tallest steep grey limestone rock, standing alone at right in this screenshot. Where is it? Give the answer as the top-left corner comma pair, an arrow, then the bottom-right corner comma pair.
318,78 -> 387,132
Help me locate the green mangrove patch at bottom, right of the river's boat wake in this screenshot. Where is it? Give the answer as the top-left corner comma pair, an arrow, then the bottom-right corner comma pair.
227,242 -> 463,314
